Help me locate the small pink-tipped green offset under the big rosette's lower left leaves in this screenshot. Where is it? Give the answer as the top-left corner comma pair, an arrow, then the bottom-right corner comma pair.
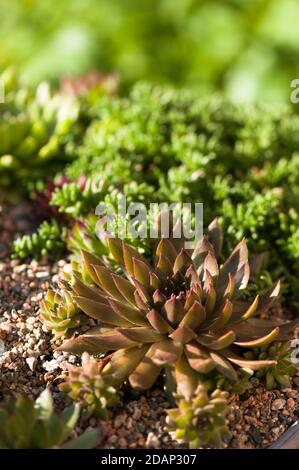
59,353 -> 119,419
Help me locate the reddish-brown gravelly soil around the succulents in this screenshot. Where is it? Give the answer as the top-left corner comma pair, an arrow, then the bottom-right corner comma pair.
0,204 -> 299,449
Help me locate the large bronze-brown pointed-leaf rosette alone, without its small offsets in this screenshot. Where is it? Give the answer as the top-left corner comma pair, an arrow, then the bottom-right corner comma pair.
61,215 -> 296,389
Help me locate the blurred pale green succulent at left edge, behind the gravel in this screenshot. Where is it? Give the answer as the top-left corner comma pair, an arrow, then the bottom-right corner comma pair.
0,68 -> 117,200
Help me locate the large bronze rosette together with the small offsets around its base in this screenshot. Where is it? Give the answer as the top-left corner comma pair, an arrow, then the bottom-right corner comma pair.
42,211 -> 298,447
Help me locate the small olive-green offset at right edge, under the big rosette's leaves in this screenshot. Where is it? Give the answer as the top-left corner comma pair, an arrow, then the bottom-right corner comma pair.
245,341 -> 298,390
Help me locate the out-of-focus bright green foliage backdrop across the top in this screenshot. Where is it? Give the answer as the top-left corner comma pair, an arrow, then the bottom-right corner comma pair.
0,0 -> 299,102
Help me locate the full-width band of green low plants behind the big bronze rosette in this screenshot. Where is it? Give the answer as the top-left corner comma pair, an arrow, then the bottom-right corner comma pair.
0,72 -> 299,304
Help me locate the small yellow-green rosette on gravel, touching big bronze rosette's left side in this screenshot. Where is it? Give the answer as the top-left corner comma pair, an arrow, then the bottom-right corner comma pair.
40,289 -> 82,338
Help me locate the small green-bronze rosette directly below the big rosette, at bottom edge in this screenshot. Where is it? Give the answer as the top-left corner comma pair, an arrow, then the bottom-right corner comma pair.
167,385 -> 230,449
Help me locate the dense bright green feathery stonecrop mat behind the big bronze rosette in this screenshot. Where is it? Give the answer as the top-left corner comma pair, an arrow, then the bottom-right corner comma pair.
7,83 -> 299,304
